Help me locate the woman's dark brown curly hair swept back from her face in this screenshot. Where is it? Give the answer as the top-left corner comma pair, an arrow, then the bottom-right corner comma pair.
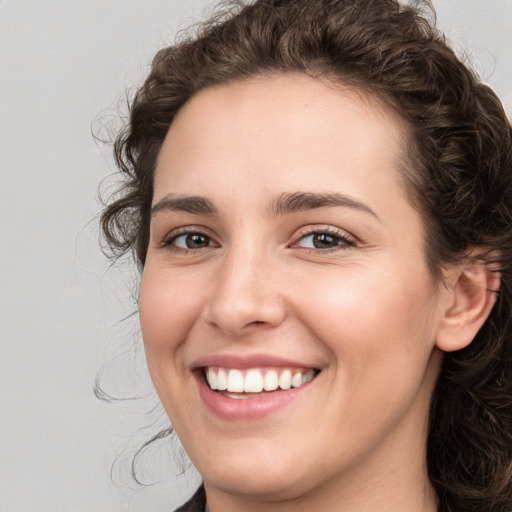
101,0 -> 512,512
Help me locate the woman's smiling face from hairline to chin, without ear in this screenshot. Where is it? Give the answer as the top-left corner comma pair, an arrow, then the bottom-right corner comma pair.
140,75 -> 448,506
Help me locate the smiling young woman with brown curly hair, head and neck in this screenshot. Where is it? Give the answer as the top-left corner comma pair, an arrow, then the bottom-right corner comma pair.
102,0 -> 512,512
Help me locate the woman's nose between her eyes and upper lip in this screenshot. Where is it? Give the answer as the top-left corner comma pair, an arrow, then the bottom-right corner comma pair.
206,244 -> 286,337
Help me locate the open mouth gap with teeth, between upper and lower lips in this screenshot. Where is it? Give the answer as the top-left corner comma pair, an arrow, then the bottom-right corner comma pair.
202,366 -> 319,399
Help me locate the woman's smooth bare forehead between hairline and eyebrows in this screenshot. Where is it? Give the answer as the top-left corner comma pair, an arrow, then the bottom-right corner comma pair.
155,74 -> 407,204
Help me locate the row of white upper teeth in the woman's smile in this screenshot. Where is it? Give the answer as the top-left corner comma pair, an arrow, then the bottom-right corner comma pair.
206,367 -> 315,397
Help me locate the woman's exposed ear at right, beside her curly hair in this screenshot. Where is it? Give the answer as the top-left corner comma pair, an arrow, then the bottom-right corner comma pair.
436,258 -> 500,352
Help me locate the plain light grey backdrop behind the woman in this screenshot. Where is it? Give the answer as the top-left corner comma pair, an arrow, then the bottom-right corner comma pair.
0,0 -> 512,512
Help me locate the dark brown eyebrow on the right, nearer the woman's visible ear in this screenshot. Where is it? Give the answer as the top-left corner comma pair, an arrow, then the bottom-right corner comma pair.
270,192 -> 379,219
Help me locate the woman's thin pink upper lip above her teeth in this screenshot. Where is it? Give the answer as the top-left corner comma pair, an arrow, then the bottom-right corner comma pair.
192,353 -> 318,369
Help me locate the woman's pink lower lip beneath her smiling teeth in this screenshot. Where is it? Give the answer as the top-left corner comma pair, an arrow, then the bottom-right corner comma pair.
197,372 -> 315,421
